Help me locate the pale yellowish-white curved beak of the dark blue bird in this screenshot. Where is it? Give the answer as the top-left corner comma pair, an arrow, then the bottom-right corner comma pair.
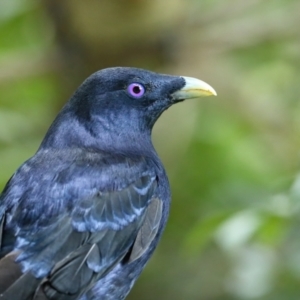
172,76 -> 217,101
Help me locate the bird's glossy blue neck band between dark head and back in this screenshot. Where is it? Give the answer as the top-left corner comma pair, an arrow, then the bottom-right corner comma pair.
40,109 -> 156,155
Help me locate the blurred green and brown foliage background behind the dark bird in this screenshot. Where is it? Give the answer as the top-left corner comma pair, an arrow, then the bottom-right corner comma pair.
0,0 -> 300,300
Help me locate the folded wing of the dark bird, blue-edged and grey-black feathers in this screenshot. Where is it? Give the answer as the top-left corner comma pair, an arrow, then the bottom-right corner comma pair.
0,155 -> 162,300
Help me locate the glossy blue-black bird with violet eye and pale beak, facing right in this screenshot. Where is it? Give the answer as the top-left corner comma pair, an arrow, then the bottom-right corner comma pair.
0,67 -> 216,300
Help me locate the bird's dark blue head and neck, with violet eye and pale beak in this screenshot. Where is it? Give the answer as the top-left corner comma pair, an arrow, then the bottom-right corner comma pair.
42,67 -> 216,154
